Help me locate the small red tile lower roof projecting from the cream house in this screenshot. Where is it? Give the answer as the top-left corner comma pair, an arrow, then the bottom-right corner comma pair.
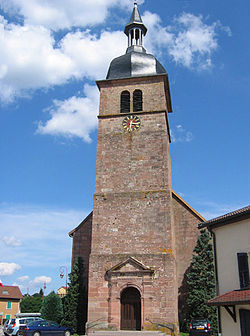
208,289 -> 250,306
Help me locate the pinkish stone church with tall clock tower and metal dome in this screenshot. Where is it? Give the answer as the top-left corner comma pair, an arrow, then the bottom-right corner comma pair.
69,2 -> 204,333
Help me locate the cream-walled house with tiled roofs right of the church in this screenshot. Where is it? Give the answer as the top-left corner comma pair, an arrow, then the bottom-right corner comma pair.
200,206 -> 250,336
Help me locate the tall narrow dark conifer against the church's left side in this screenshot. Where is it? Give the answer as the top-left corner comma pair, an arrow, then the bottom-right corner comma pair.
61,257 -> 87,333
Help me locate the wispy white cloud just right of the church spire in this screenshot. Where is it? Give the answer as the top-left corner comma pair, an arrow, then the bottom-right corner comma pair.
143,12 -> 231,70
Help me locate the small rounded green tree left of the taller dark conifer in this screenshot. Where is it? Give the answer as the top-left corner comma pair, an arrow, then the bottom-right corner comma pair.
40,292 -> 63,323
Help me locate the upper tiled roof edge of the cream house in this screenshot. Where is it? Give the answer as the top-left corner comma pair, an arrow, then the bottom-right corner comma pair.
199,205 -> 250,229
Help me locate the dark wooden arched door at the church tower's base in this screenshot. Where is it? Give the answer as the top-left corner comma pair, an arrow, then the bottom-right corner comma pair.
121,287 -> 141,330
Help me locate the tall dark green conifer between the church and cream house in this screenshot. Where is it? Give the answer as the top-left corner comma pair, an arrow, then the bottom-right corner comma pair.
186,230 -> 217,331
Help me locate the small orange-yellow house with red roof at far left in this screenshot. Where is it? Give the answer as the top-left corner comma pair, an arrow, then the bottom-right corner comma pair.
0,286 -> 23,324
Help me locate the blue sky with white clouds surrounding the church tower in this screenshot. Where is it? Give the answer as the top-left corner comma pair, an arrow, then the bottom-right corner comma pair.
0,0 -> 250,293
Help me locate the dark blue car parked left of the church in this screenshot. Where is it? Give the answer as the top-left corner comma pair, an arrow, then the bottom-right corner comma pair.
19,320 -> 74,336
